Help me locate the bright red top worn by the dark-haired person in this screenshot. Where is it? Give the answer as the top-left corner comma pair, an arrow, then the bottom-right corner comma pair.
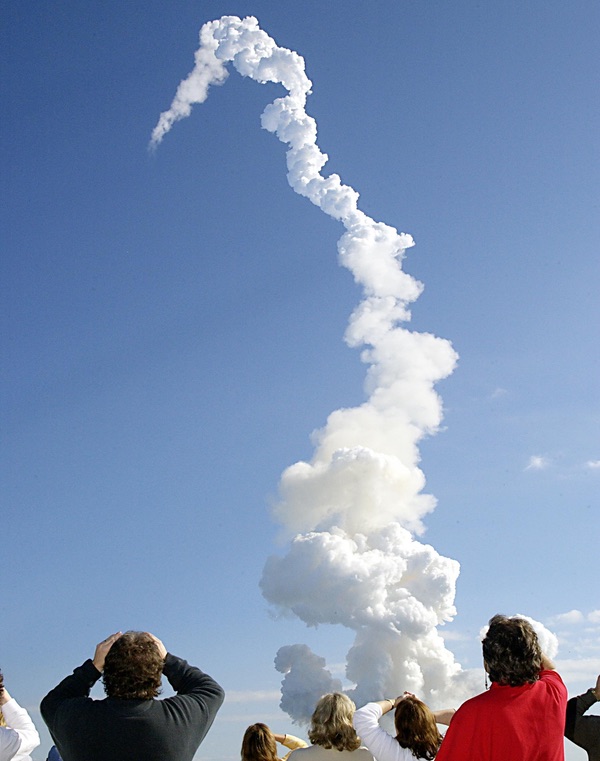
435,671 -> 567,761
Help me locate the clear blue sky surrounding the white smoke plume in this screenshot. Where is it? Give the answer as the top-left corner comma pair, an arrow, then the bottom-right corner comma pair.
0,0 -> 600,759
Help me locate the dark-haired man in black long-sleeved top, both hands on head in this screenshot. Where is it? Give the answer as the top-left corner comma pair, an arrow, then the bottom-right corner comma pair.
41,631 -> 224,761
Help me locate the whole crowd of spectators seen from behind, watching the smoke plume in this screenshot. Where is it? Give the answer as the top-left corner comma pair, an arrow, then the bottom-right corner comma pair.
0,615 -> 600,761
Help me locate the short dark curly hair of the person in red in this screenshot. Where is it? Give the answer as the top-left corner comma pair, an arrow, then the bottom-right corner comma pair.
483,614 -> 542,687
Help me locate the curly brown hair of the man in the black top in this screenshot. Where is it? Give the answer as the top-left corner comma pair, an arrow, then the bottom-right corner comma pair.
102,632 -> 164,700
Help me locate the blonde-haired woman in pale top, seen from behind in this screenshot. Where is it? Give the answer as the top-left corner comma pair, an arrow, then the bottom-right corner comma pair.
290,692 -> 374,761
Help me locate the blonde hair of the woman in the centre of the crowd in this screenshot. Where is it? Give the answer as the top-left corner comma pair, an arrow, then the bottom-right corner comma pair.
308,692 -> 360,750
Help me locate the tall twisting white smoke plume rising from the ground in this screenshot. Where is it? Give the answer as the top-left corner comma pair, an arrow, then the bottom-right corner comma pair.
151,16 -> 478,721
